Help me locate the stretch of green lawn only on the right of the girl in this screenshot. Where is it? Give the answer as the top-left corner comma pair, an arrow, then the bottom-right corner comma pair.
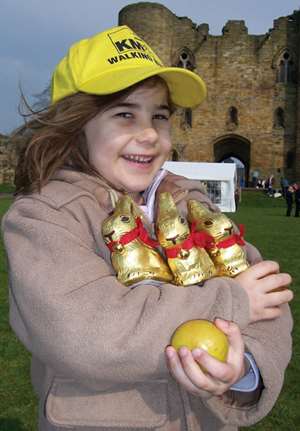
230,191 -> 300,431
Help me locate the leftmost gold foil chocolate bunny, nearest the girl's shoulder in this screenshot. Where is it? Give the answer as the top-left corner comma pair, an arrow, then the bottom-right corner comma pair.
102,196 -> 173,286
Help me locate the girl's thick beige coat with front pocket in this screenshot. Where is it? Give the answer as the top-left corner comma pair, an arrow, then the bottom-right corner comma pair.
2,170 -> 292,431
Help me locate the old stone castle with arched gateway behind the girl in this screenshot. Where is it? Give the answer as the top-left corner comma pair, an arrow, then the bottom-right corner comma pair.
0,2 -> 300,184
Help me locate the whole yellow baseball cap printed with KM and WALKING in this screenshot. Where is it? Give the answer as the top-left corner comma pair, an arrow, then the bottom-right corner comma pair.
51,25 -> 206,108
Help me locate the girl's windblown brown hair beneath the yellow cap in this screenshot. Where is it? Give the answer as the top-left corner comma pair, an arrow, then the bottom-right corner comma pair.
15,76 -> 174,194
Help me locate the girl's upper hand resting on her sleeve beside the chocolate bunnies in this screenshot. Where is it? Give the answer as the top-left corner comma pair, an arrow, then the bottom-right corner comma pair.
235,260 -> 293,322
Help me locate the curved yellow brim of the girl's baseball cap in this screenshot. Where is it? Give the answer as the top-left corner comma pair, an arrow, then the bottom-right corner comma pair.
78,67 -> 206,108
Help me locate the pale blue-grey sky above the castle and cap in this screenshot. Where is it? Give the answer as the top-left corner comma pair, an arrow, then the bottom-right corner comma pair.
0,0 -> 300,133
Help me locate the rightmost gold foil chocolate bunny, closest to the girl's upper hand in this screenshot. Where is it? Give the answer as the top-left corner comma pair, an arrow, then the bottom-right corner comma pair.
188,200 -> 249,277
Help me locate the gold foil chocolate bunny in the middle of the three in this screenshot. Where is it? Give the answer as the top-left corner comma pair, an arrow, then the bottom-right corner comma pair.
156,192 -> 215,286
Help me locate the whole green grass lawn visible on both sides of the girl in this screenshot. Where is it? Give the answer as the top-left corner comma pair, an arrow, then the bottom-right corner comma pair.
0,189 -> 300,431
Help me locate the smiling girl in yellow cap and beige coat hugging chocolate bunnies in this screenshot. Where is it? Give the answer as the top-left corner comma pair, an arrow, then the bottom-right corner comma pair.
3,26 -> 292,431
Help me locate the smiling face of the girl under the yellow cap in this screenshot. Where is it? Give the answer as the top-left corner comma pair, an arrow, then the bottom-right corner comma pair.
84,84 -> 171,200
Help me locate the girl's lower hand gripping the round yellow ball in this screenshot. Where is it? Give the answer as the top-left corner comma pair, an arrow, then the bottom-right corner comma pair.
165,319 -> 245,398
